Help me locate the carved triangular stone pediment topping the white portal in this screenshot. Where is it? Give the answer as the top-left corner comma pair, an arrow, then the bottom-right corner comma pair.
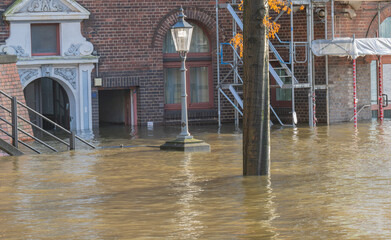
3,0 -> 90,21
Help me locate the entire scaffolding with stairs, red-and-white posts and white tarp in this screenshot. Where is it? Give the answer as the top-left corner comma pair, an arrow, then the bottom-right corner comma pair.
216,0 -> 391,127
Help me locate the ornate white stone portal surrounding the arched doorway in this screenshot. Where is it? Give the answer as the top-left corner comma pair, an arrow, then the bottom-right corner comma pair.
0,0 -> 98,130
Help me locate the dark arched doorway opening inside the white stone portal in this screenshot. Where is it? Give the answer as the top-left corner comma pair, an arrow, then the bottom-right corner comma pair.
24,78 -> 70,130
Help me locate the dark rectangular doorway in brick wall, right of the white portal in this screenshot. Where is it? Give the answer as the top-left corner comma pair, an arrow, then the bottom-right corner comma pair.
99,89 -> 137,126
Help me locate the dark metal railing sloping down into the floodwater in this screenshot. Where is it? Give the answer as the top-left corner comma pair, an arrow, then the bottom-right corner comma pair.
0,90 -> 96,154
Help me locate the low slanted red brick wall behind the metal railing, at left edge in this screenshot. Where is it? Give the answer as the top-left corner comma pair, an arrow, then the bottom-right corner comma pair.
0,55 -> 32,143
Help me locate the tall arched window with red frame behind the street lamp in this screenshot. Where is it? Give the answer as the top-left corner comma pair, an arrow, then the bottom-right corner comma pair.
163,23 -> 213,109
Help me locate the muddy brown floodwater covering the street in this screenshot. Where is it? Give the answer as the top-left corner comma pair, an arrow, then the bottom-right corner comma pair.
0,121 -> 391,239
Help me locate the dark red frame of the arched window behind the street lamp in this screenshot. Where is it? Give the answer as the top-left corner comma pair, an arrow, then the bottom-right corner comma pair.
162,20 -> 214,110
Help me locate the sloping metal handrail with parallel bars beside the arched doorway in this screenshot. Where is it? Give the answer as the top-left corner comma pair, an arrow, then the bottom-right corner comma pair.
0,90 -> 96,155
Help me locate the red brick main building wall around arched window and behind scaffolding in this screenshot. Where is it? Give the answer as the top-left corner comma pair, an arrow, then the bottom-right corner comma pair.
0,0 -> 391,124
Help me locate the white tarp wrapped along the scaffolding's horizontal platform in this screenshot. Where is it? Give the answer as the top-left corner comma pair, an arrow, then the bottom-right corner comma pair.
312,38 -> 391,59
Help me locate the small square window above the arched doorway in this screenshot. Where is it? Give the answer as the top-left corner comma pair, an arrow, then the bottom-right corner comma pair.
31,24 -> 60,56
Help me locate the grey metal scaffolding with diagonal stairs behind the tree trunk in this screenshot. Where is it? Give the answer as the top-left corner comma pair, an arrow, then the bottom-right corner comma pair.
216,0 -> 334,127
